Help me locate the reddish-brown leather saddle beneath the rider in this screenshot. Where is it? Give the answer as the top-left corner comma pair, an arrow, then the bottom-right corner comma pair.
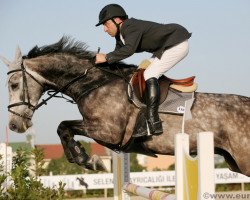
131,69 -> 195,104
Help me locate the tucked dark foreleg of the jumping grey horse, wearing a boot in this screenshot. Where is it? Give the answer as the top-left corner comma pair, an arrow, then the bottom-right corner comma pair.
57,120 -> 106,171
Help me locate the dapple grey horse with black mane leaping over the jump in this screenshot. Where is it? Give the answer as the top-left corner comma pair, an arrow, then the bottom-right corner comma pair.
1,37 -> 250,176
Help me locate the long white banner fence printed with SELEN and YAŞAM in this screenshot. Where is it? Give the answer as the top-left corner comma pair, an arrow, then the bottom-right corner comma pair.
40,169 -> 250,190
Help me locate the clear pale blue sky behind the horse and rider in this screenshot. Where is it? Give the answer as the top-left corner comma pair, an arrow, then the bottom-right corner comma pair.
0,0 -> 250,144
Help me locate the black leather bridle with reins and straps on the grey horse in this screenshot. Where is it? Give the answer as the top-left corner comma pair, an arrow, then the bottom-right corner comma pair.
7,58 -> 130,120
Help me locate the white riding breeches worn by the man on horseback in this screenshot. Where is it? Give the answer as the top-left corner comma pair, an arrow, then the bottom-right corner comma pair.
144,40 -> 189,80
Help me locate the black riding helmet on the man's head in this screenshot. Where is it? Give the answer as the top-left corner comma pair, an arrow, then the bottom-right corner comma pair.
96,4 -> 128,26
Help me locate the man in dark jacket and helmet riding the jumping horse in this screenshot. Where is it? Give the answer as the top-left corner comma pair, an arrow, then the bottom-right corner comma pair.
95,4 -> 191,135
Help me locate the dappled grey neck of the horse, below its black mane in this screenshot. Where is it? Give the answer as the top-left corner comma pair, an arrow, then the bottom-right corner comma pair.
27,56 -> 131,100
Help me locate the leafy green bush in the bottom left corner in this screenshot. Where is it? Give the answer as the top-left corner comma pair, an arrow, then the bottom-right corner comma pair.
0,148 -> 65,200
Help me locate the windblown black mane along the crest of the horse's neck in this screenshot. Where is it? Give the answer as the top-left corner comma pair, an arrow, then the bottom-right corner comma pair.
26,36 -> 94,59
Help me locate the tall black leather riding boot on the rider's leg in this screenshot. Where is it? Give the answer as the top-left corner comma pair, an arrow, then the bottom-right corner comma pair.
146,78 -> 163,135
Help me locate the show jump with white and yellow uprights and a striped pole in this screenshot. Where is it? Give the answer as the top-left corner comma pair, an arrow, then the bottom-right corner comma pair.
113,132 -> 215,200
